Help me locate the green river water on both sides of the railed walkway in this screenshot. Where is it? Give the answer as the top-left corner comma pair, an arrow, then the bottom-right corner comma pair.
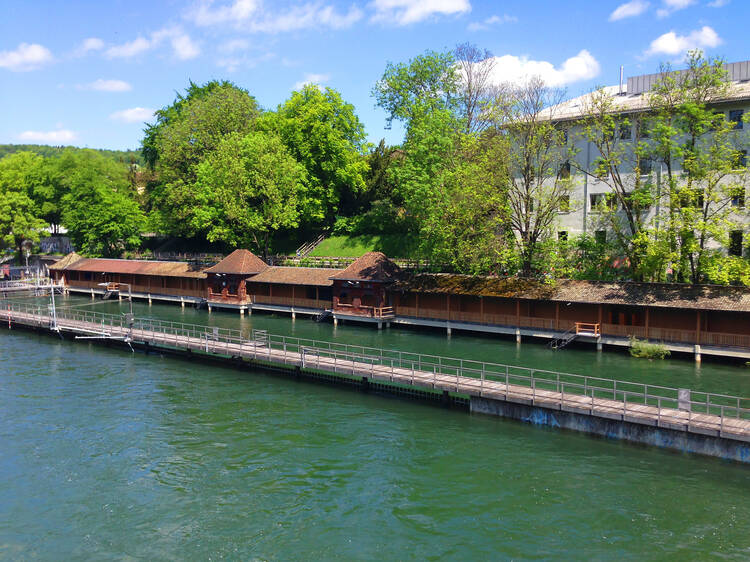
0,298 -> 750,560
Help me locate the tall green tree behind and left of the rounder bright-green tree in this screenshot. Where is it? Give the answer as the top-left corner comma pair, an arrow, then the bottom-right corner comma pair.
143,82 -> 260,235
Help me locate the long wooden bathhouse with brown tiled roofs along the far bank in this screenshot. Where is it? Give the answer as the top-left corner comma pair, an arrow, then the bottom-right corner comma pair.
45,250 -> 750,358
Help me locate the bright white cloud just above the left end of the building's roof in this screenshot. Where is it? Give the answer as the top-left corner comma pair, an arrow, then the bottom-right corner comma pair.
484,49 -> 600,87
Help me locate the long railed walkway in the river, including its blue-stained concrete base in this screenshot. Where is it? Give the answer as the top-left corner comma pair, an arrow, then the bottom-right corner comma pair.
0,302 -> 750,462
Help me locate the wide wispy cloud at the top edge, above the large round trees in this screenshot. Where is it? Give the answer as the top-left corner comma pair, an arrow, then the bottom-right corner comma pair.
185,0 -> 363,33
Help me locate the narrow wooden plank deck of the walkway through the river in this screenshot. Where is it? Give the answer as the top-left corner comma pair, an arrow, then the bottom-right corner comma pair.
0,308 -> 750,442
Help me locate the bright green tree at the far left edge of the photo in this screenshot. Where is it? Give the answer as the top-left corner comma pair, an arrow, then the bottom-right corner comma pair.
0,152 -> 46,256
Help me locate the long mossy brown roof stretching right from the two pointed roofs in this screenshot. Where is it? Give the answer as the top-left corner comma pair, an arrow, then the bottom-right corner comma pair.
393,273 -> 750,312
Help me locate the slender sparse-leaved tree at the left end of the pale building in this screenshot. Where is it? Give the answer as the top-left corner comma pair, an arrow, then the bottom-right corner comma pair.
501,78 -> 570,276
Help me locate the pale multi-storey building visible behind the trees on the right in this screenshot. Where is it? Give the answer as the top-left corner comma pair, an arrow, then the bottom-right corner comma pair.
540,61 -> 750,247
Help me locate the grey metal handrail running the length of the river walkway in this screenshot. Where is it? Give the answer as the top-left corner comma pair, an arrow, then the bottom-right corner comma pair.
0,301 -> 750,427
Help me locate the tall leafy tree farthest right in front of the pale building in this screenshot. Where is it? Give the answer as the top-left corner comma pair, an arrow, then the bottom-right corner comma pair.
648,51 -> 745,283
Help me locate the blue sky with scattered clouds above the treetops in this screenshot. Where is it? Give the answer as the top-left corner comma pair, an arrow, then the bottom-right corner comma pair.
0,0 -> 750,149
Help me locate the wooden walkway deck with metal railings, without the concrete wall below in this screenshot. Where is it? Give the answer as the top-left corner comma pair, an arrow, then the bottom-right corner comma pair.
0,302 -> 750,462
